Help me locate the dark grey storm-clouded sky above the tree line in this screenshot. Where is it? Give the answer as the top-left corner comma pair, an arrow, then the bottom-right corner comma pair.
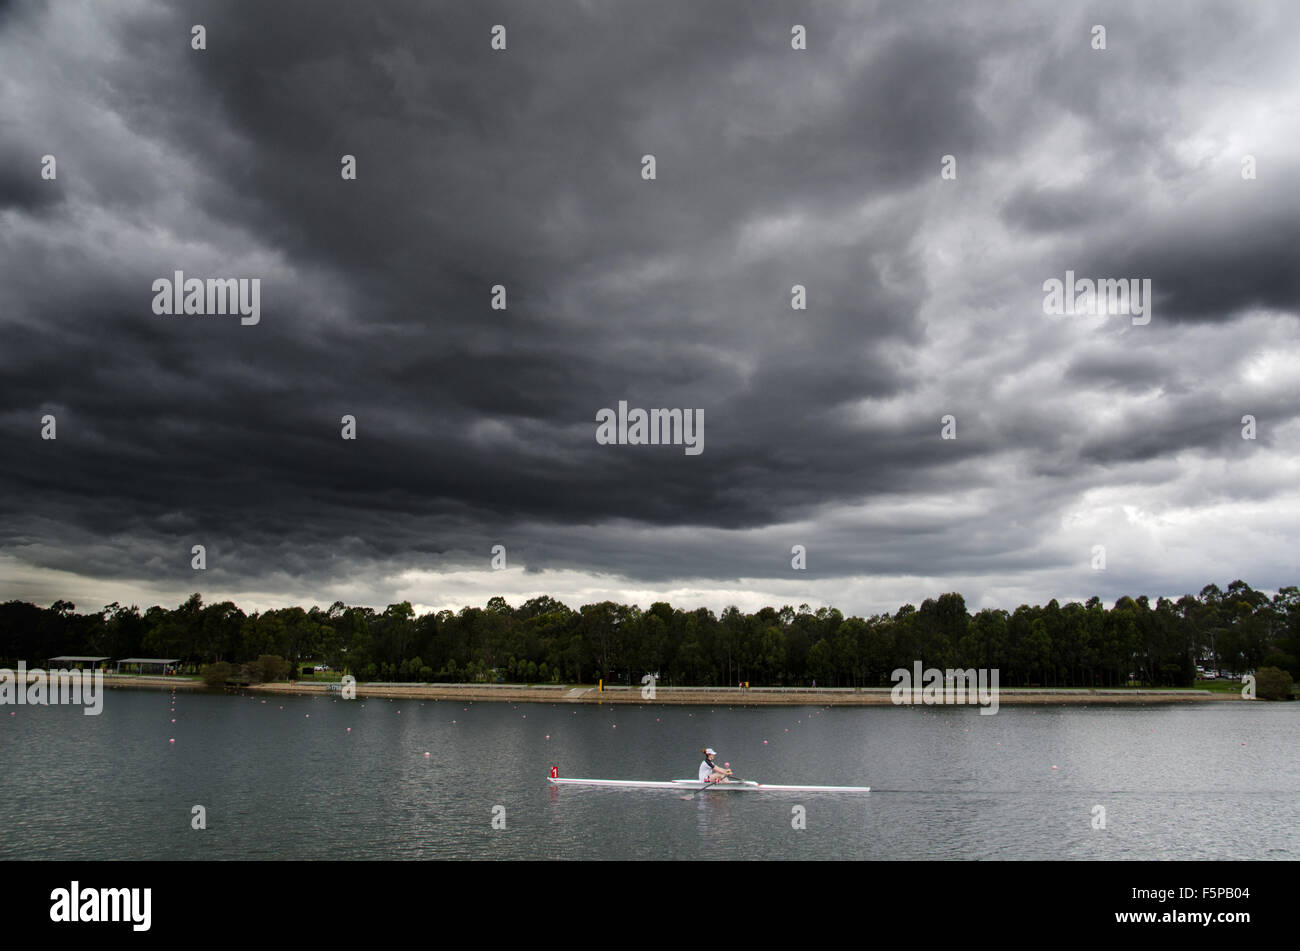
0,0 -> 1300,613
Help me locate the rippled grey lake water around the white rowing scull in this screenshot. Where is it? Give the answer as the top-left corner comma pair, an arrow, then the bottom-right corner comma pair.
0,690 -> 1300,860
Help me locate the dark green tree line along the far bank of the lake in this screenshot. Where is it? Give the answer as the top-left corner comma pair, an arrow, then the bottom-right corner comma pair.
0,581 -> 1300,687
